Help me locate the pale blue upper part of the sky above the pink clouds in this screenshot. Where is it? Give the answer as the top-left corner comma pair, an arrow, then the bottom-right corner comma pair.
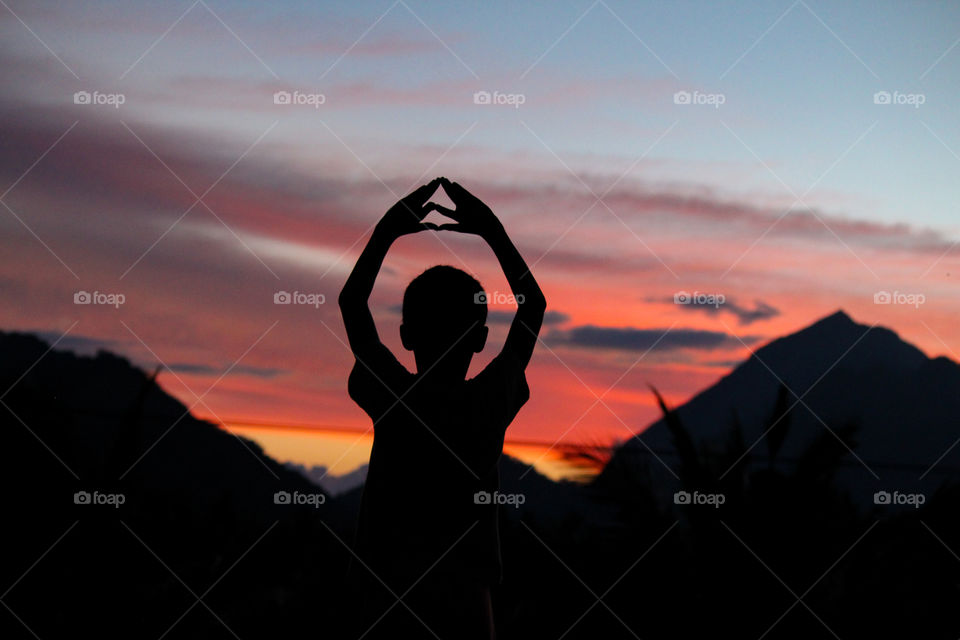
11,1 -> 960,225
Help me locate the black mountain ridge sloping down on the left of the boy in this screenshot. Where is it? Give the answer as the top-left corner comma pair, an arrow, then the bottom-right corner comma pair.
0,332 -> 320,508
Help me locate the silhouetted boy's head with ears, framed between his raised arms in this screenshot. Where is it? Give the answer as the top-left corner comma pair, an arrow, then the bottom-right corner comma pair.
400,266 -> 487,376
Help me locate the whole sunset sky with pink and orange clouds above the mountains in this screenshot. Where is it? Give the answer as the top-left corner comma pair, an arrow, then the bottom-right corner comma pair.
0,0 -> 960,480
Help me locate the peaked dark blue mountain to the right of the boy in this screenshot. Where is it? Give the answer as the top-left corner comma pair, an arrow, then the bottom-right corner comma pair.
607,311 -> 960,504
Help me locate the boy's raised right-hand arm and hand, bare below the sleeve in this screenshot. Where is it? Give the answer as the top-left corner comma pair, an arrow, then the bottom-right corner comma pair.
434,178 -> 547,367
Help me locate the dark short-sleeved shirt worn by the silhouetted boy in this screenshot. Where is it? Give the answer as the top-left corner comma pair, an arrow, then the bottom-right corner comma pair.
348,344 -> 530,584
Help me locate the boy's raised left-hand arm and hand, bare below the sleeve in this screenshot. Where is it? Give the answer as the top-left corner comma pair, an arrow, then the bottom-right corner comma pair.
339,178 -> 440,360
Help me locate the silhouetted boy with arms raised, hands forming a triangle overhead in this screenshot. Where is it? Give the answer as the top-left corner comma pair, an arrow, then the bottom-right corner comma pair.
340,178 -> 546,639
